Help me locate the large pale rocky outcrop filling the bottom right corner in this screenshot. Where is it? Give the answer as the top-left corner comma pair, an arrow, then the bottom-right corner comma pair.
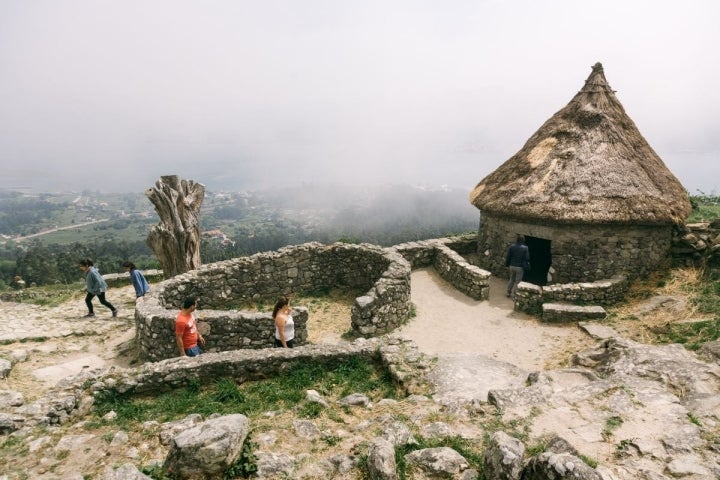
488,338 -> 720,480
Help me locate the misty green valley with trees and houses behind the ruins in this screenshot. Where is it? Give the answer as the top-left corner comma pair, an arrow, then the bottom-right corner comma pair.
0,184 -> 479,287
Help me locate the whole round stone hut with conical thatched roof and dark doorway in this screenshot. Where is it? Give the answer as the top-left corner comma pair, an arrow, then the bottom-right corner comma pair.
470,63 -> 691,285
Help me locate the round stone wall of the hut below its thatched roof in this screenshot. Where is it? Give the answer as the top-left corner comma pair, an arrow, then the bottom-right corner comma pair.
477,214 -> 672,283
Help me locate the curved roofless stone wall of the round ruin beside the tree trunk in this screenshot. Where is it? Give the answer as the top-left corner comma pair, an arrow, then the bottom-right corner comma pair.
135,243 -> 410,361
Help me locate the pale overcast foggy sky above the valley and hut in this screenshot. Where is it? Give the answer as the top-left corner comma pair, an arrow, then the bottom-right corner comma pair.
0,0 -> 720,194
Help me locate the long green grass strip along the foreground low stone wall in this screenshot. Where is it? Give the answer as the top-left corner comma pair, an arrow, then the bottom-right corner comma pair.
95,357 -> 397,429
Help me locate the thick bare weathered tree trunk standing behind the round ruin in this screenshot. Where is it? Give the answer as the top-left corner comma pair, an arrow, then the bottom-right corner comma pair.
145,175 -> 205,278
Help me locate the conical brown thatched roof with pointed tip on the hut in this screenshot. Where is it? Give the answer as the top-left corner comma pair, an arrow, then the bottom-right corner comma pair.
470,63 -> 690,225
